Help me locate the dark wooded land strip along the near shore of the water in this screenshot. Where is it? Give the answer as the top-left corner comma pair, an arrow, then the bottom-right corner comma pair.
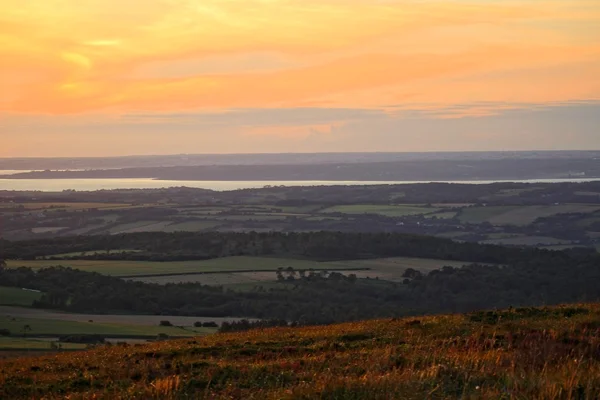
0,182 -> 600,207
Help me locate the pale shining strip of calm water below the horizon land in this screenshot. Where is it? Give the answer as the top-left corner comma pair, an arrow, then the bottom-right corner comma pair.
0,178 -> 600,192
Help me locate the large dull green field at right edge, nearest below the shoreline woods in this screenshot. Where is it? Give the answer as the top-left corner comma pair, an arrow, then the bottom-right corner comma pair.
458,204 -> 600,226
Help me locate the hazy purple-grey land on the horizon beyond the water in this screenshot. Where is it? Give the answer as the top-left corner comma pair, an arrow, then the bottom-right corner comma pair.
0,151 -> 600,181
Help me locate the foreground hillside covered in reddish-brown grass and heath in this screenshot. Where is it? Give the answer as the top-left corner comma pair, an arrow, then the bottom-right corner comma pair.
0,304 -> 600,399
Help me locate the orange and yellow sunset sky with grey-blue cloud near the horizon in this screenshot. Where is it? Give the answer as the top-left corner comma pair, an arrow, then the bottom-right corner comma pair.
0,0 -> 600,157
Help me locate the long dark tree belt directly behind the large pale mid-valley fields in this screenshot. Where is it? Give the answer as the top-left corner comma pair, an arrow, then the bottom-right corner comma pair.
0,232 -> 593,264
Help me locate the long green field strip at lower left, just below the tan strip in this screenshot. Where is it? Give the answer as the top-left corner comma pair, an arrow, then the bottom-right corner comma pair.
0,315 -> 214,337
